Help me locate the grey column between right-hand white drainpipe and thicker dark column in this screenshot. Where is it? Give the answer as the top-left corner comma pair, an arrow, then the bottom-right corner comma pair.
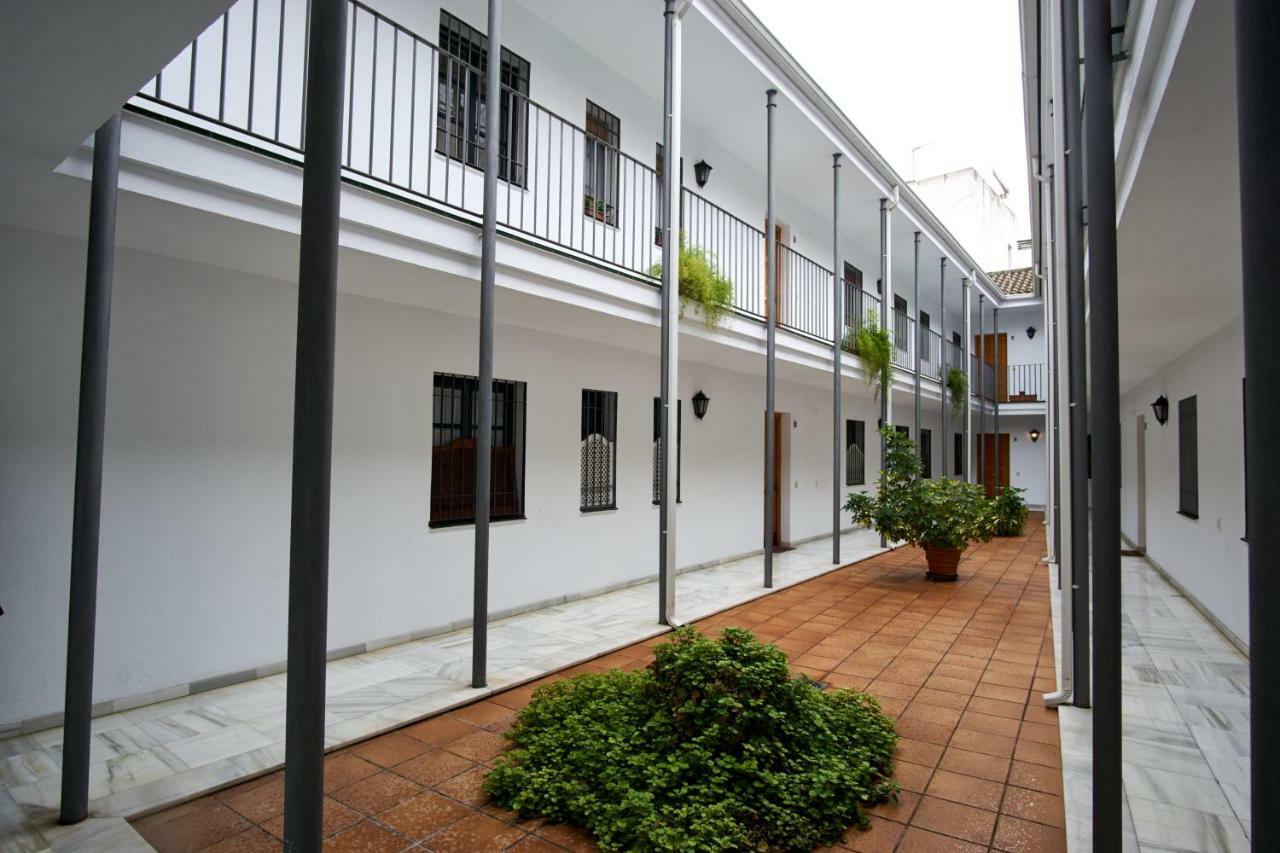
1061,0 -> 1091,708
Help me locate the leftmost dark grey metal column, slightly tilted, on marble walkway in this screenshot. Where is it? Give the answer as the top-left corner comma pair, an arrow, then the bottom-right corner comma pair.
59,113 -> 120,824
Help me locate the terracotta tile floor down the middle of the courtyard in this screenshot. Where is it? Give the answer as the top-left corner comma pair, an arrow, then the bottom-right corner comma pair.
134,516 -> 1066,853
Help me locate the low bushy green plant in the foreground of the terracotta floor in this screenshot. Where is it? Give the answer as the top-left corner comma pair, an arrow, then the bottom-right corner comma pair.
485,628 -> 897,850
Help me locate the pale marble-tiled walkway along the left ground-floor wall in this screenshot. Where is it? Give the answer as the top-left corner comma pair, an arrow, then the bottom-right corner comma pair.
0,530 -> 882,853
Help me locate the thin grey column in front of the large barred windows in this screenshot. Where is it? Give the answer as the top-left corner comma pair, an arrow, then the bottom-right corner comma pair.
471,0 -> 502,688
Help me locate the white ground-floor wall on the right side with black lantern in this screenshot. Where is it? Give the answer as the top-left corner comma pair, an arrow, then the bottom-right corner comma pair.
1120,316 -> 1244,640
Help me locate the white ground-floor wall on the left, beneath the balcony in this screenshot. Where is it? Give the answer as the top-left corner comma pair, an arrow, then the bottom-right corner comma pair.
0,227 -> 885,725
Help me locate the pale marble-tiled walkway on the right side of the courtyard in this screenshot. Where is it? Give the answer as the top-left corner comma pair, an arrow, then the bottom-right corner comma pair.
1061,557 -> 1251,852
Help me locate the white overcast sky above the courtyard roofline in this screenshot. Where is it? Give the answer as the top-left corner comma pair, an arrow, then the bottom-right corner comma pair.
746,0 -> 1029,230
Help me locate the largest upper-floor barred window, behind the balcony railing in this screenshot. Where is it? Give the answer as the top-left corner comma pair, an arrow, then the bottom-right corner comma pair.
435,9 -> 529,187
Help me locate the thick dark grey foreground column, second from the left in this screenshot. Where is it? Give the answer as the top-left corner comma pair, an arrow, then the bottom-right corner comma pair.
284,0 -> 347,852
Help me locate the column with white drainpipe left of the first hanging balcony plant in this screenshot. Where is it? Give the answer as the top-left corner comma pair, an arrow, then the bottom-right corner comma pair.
658,0 -> 681,612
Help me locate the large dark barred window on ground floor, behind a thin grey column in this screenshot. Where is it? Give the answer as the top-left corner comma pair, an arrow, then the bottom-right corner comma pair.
430,373 -> 525,528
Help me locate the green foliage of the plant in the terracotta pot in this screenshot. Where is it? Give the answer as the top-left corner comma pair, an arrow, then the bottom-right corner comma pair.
845,427 -> 995,549
